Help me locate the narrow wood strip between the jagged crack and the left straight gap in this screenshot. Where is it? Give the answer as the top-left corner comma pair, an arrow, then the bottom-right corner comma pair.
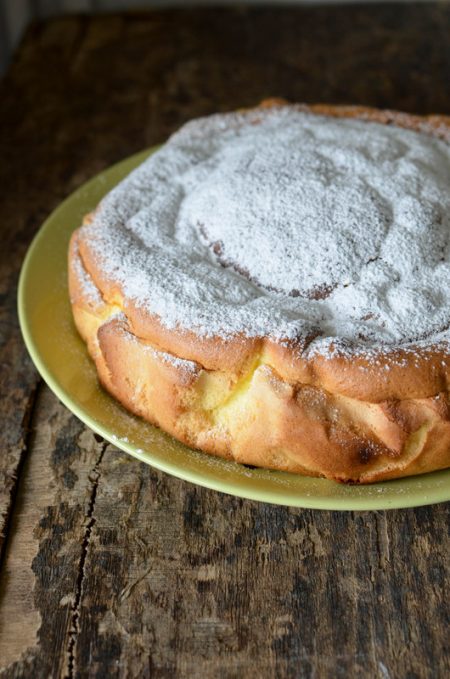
0,387 -> 105,676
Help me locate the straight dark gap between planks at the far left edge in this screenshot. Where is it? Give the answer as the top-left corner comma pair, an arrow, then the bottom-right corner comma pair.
0,379 -> 43,573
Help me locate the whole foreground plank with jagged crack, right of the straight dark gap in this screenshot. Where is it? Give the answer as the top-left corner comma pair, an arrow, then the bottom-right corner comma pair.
0,388 -> 450,678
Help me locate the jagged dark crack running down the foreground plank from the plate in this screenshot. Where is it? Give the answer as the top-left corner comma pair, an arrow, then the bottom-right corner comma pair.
65,441 -> 109,679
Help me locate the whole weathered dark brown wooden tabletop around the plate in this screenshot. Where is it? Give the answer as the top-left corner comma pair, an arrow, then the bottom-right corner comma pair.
0,4 -> 450,679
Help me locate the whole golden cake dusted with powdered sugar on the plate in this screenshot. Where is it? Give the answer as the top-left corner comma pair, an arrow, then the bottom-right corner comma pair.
69,101 -> 450,483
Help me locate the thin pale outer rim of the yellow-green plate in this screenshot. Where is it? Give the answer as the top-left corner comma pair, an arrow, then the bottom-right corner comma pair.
17,146 -> 450,511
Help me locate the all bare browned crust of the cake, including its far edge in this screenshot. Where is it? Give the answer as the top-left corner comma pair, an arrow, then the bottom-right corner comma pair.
69,101 -> 450,482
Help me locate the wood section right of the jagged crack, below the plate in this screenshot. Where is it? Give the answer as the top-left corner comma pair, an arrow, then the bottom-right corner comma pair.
70,455 -> 449,677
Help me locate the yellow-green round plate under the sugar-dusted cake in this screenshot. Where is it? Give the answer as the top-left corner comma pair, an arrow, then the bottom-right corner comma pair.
19,150 -> 450,510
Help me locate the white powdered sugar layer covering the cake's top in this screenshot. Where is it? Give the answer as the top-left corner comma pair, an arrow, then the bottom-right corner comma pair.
83,107 -> 450,352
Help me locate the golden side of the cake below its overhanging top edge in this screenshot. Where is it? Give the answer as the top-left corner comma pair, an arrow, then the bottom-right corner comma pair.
70,234 -> 450,483
